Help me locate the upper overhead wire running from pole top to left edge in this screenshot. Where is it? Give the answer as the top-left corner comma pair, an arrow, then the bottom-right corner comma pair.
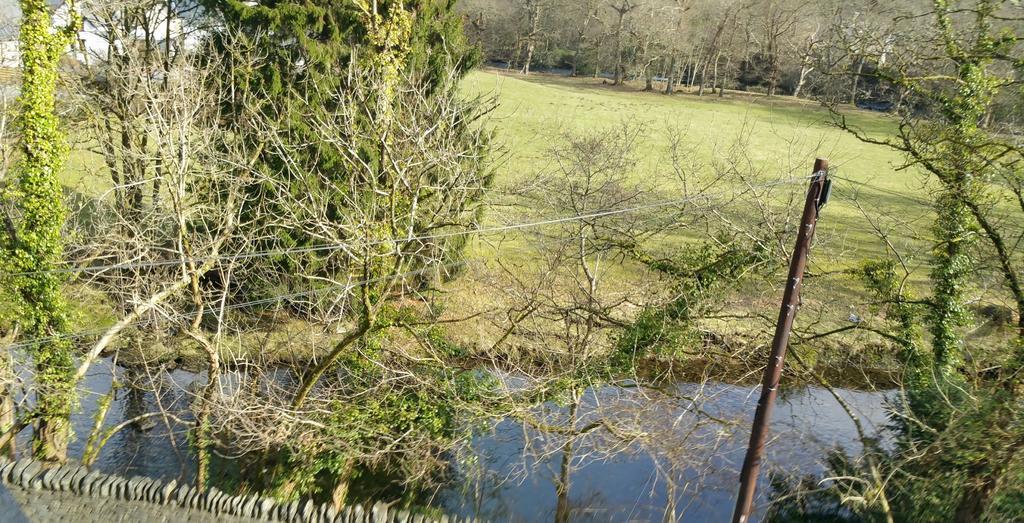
9,177 -> 810,276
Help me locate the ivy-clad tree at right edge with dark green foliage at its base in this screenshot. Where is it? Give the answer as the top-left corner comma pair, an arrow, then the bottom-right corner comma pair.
770,0 -> 1024,522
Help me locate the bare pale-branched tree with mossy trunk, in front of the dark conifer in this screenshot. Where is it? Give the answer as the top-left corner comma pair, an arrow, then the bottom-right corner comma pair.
166,61 -> 503,505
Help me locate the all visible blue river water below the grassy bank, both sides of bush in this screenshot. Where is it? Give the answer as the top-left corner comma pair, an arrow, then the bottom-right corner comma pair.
20,360 -> 886,522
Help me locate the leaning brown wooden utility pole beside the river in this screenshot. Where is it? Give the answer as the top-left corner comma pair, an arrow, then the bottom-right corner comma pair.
732,159 -> 830,523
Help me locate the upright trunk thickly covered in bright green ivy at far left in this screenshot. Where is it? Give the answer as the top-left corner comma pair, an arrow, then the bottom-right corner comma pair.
3,0 -> 81,461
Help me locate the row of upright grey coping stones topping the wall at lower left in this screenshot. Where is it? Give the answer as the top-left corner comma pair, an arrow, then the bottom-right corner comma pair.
0,457 -> 471,523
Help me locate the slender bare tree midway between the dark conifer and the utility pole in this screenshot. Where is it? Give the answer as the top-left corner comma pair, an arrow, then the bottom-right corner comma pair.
492,127 -> 679,522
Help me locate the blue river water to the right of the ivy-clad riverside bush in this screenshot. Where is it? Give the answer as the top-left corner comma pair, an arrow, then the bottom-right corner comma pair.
441,384 -> 886,522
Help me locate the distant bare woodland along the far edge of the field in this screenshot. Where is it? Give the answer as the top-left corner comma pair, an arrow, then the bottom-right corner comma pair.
459,0 -> 1015,118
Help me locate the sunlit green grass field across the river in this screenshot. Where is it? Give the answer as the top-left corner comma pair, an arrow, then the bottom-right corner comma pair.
54,70 -> 983,370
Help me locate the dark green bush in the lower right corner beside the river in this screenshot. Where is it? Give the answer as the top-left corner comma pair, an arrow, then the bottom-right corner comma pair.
767,391 -> 1024,523
